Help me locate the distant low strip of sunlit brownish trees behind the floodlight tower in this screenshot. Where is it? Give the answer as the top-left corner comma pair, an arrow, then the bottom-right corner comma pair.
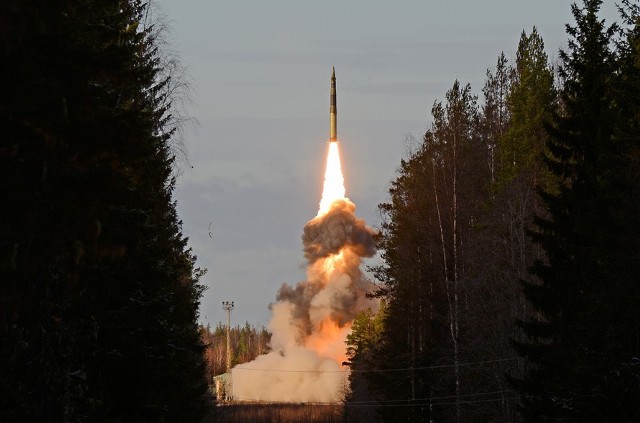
200,322 -> 271,383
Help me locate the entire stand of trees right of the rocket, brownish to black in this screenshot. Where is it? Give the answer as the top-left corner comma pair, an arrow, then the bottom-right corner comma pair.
347,0 -> 640,422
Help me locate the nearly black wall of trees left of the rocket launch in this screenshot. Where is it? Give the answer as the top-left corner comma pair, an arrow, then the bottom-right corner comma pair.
0,0 -> 208,422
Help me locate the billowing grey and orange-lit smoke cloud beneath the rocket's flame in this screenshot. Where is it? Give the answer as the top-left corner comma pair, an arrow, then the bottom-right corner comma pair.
232,198 -> 375,402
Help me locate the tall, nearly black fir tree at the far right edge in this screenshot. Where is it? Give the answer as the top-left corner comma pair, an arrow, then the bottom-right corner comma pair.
516,0 -> 640,422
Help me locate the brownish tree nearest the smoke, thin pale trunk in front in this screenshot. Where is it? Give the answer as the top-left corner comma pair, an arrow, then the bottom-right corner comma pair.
372,81 -> 489,421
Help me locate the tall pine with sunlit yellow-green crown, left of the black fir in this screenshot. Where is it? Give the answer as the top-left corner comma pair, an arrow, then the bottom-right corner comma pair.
469,27 -> 556,394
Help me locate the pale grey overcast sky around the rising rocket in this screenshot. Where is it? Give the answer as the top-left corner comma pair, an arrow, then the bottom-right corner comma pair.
157,0 -> 616,325
